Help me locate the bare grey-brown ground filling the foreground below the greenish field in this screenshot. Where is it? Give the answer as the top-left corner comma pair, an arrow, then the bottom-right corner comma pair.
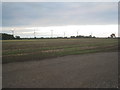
3,52 -> 118,88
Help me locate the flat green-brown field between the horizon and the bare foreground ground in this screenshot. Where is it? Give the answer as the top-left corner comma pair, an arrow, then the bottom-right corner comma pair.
2,38 -> 118,63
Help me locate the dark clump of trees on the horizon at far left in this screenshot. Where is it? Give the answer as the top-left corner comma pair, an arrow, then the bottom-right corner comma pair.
0,33 -> 21,40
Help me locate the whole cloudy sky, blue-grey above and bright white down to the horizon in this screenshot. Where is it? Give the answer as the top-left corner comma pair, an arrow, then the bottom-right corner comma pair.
2,2 -> 118,37
